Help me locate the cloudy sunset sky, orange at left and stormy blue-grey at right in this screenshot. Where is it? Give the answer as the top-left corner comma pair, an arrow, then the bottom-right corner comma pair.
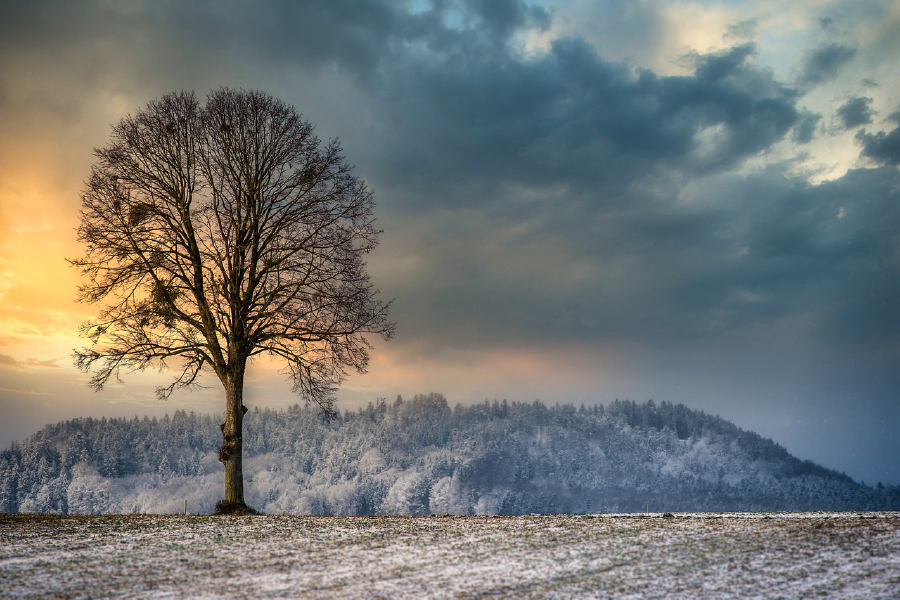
0,0 -> 900,484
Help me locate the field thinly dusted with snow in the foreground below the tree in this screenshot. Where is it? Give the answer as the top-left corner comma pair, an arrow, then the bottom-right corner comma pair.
0,512 -> 900,598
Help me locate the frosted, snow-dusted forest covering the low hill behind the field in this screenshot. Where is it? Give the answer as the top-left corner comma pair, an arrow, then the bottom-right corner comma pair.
0,394 -> 900,515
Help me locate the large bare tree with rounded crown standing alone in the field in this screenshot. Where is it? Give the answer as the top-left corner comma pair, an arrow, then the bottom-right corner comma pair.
71,88 -> 394,511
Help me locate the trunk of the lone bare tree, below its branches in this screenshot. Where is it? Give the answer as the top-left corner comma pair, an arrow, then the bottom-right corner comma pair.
219,364 -> 247,512
